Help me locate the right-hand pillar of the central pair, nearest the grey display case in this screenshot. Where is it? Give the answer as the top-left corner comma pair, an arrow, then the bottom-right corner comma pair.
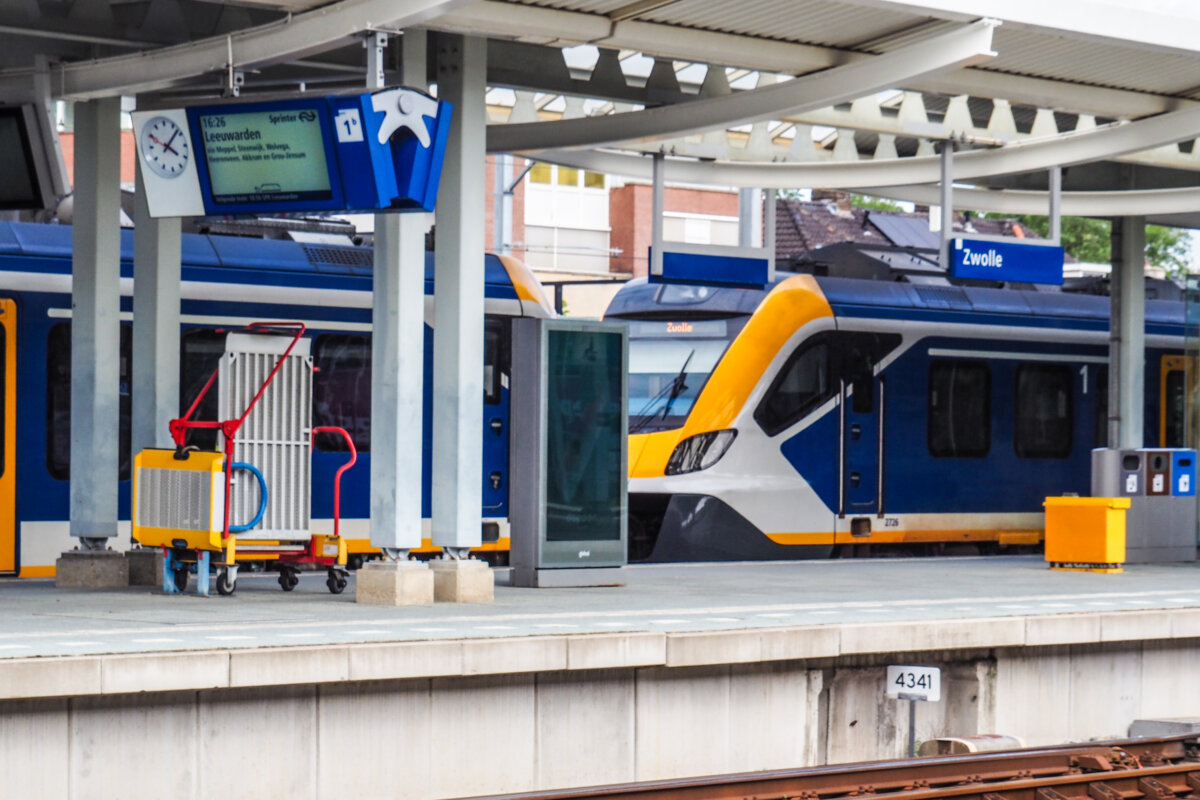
432,36 -> 487,557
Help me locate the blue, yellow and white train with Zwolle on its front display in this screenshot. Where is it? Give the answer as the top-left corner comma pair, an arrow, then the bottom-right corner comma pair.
606,273 -> 1184,561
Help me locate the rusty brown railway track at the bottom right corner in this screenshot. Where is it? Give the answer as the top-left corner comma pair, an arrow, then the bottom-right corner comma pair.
465,736 -> 1200,800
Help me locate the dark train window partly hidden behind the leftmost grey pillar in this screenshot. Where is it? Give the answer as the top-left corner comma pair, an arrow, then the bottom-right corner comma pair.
46,323 -> 133,481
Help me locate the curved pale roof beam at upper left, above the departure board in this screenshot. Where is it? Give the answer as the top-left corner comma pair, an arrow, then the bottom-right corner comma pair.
0,0 -> 472,100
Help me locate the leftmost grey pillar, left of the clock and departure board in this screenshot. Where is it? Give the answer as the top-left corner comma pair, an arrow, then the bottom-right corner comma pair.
71,97 -> 121,549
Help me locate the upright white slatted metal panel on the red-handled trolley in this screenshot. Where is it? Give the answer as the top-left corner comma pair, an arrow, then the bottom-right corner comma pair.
217,333 -> 312,541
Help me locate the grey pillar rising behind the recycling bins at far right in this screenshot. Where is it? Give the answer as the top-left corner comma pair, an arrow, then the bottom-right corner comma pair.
1109,217 -> 1146,450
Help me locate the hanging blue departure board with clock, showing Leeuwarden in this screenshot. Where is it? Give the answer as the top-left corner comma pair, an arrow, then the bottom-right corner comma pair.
133,89 -> 451,217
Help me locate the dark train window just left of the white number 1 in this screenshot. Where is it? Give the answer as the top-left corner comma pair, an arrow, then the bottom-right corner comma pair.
1013,363 -> 1075,458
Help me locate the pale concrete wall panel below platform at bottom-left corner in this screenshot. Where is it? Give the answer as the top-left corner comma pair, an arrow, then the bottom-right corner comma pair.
0,695 -> 71,798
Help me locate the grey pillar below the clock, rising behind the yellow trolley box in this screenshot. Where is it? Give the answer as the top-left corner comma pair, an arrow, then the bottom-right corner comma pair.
130,164 -> 181,453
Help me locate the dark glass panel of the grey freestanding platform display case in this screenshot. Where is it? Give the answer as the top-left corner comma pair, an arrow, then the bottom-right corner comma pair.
546,330 -> 624,542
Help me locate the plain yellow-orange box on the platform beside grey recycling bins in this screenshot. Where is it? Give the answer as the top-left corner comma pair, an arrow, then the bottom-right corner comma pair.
1044,498 -> 1129,572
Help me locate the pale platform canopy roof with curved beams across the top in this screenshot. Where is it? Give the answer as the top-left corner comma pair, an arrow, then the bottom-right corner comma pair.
0,0 -> 1200,224
